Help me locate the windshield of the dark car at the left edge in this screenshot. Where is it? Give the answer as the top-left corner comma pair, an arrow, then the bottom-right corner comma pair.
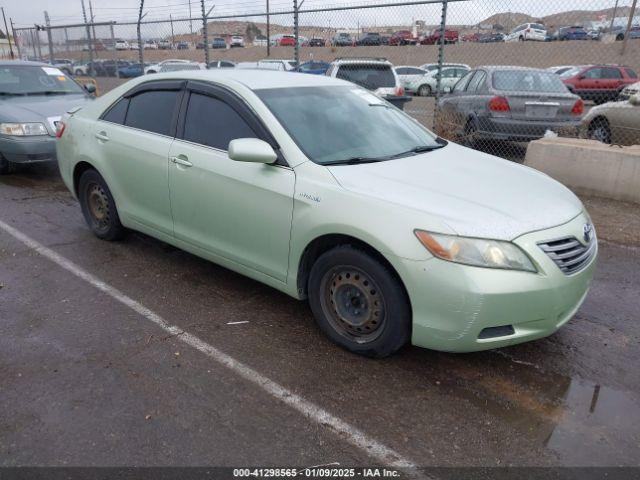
0,65 -> 84,95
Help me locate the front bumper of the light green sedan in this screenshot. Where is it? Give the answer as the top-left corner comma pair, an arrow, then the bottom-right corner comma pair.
392,214 -> 597,352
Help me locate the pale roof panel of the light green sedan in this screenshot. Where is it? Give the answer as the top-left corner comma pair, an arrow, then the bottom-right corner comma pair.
134,68 -> 353,90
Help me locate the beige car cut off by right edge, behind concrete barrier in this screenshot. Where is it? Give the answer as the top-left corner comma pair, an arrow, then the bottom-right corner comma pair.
581,93 -> 640,145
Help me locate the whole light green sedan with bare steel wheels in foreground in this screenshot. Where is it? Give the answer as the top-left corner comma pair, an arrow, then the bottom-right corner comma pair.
57,70 -> 597,357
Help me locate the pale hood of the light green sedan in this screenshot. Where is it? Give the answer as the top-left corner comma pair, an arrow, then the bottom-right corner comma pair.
328,143 -> 583,240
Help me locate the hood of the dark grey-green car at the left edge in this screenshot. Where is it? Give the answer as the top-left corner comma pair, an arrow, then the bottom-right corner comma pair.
0,93 -> 92,133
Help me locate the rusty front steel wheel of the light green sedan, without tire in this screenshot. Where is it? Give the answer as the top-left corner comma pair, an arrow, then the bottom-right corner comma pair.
320,265 -> 386,343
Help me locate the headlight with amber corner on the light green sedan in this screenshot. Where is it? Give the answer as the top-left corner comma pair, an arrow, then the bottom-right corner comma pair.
414,230 -> 537,272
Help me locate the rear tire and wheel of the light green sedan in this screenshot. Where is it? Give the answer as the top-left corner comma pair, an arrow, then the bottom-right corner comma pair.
78,170 -> 125,241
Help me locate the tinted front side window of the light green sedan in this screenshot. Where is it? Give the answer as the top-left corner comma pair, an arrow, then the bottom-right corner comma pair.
183,93 -> 257,150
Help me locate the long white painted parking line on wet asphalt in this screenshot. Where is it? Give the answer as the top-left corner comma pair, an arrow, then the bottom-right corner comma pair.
0,220 -> 416,469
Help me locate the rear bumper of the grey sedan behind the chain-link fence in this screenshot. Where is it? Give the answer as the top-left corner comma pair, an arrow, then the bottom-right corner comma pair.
478,117 -> 580,141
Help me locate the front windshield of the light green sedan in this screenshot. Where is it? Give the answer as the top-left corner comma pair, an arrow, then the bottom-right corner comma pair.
256,86 -> 442,165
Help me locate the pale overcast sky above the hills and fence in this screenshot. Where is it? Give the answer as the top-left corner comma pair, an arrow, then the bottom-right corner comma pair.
0,0 -> 631,29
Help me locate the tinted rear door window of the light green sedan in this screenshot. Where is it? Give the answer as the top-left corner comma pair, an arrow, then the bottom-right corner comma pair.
126,90 -> 178,135
